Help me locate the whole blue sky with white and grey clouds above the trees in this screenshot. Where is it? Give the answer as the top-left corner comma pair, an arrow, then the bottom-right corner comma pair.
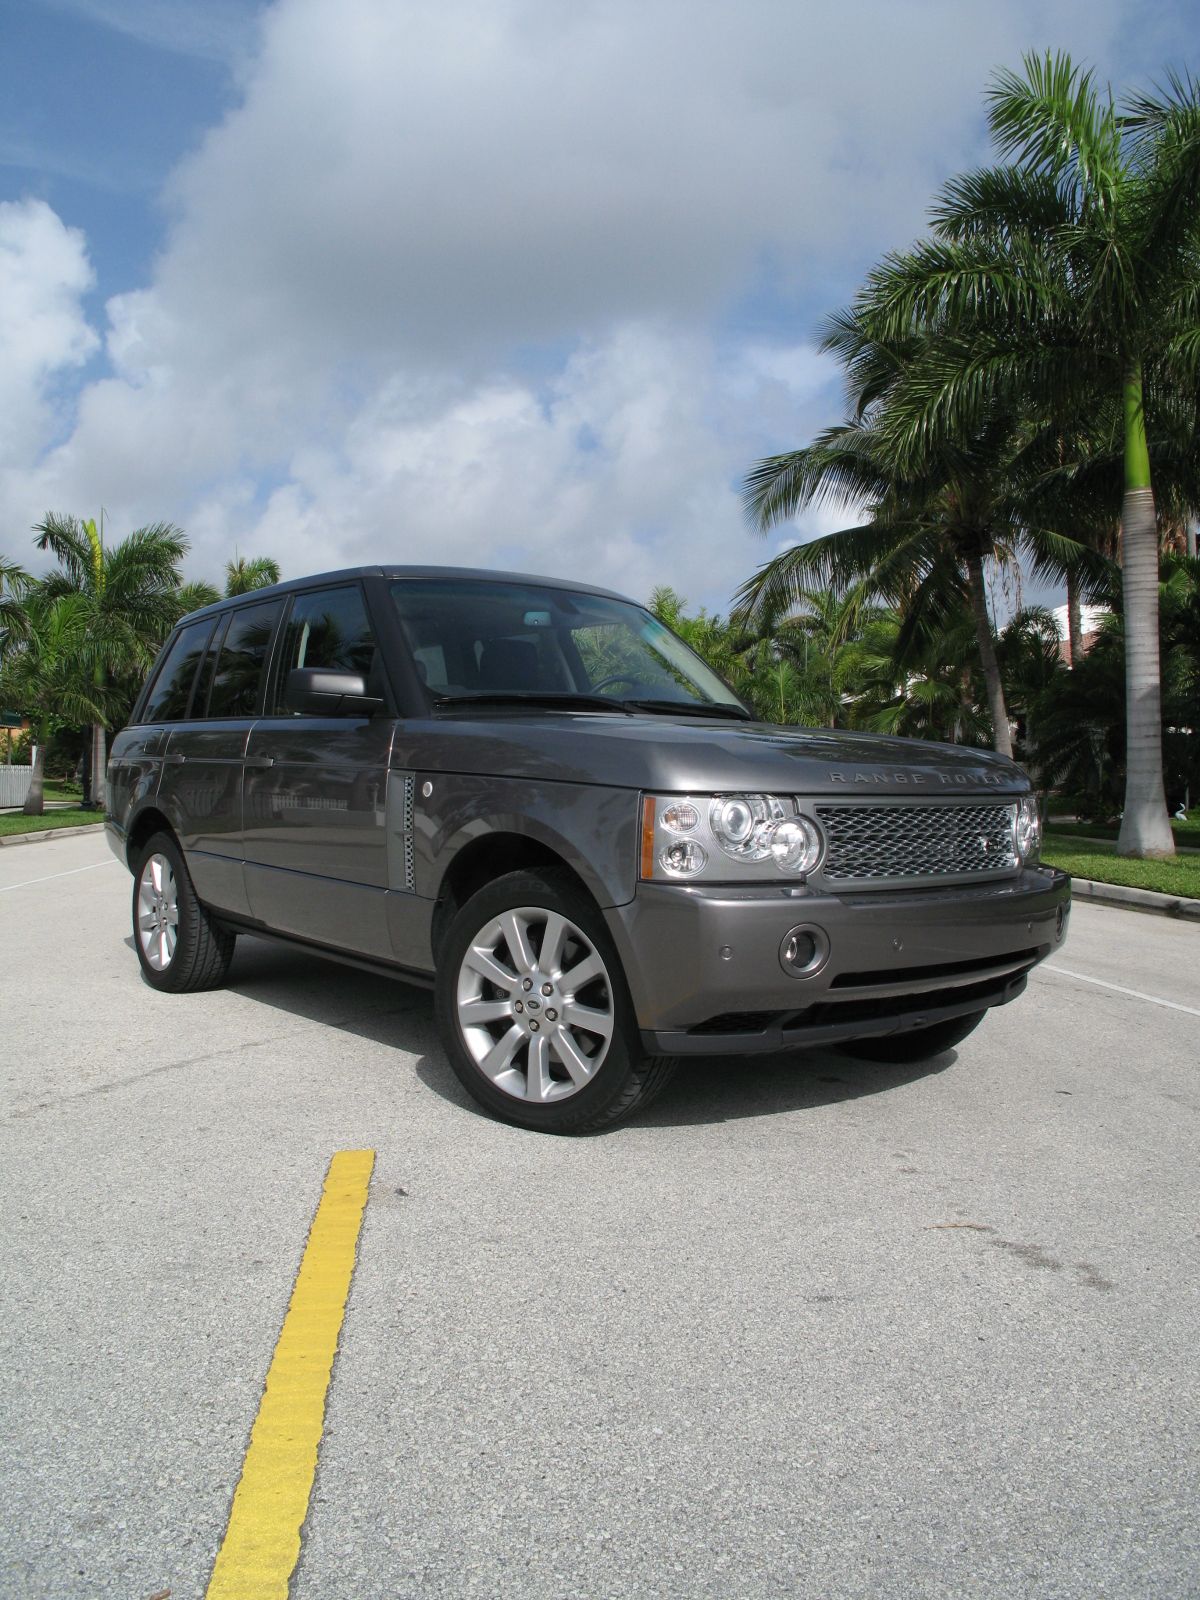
0,0 -> 1197,610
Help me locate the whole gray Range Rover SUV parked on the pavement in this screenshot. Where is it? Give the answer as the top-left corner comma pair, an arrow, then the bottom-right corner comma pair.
107,566 -> 1070,1133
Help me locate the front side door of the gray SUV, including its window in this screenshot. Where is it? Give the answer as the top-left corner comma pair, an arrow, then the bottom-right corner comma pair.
243,582 -> 392,960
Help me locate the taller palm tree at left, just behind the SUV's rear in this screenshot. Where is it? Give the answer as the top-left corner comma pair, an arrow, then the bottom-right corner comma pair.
34,512 -> 187,806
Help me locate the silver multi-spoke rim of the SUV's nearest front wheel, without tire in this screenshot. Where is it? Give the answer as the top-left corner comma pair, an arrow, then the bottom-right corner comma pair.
458,906 -> 616,1101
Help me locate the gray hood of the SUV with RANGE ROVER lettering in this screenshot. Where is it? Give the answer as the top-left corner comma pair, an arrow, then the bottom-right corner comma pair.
392,709 -> 1030,797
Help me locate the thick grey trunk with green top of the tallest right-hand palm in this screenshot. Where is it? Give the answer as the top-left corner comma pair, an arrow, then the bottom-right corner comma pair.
1117,366 -> 1174,856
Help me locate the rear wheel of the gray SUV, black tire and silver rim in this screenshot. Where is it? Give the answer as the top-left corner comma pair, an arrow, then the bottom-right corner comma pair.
133,834 -> 235,995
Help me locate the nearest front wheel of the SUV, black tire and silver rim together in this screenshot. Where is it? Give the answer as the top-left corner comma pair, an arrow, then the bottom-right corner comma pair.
435,870 -> 675,1134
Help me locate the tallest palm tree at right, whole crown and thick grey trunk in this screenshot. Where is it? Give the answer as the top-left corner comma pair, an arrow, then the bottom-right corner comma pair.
861,54 -> 1200,854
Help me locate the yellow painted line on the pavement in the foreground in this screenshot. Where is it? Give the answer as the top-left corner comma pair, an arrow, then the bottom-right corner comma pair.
205,1150 -> 374,1600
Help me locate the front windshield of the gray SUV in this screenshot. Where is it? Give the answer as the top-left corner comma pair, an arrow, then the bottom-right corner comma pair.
392,578 -> 744,715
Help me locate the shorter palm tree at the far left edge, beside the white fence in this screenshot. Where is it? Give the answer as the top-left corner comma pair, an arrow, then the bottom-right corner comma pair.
0,592 -> 110,816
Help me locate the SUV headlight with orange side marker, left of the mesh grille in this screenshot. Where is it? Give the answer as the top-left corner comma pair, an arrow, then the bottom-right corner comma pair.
642,794 -> 824,883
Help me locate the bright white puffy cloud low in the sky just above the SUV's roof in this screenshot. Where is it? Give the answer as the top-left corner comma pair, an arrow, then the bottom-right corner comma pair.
202,323 -> 827,603
